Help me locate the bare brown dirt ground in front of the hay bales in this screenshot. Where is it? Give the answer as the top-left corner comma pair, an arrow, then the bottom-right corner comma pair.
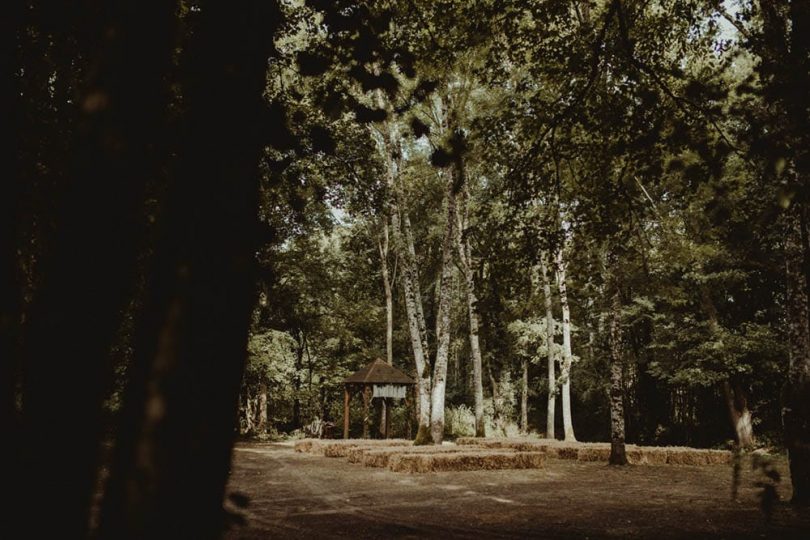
226,444 -> 810,540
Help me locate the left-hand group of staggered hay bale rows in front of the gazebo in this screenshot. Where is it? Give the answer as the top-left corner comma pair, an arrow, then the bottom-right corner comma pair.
295,439 -> 546,473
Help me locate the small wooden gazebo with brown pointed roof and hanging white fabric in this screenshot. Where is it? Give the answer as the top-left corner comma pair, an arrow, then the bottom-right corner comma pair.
343,358 -> 416,439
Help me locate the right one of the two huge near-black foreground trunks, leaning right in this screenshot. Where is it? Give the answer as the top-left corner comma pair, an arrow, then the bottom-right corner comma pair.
100,1 -> 279,538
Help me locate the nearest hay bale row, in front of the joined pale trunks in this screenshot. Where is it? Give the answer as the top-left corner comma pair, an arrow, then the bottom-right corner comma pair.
388,450 -> 546,473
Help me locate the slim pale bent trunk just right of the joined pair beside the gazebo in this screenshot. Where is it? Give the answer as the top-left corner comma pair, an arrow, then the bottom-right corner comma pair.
456,186 -> 486,437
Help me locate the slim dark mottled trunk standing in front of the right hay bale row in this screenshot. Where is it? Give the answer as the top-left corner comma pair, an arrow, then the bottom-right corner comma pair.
609,277 -> 627,465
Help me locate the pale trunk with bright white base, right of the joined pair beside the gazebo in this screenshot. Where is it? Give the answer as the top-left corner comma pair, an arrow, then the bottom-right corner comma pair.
430,170 -> 454,444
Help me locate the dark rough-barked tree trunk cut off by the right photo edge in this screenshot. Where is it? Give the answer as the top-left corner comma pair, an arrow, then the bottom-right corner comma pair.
782,202 -> 810,505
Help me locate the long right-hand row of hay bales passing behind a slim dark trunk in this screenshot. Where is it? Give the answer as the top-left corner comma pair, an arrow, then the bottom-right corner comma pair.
456,437 -> 732,465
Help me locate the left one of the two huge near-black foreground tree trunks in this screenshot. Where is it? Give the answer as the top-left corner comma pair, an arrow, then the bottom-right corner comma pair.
12,2 -> 174,538
